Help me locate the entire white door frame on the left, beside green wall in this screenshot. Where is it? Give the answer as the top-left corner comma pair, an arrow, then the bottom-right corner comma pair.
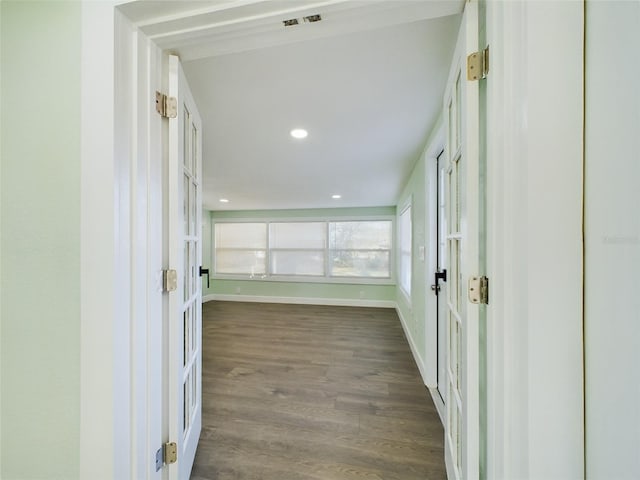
79,1 -> 174,480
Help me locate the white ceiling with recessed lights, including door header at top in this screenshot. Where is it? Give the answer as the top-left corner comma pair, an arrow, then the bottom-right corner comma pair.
121,0 -> 464,210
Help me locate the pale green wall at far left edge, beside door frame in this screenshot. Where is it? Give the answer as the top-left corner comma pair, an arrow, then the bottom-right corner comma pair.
0,1 -> 81,480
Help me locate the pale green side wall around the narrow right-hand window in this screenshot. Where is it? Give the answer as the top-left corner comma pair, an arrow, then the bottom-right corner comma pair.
396,150 -> 429,359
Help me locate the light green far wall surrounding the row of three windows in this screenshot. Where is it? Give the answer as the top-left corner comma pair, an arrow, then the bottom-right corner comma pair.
202,207 -> 396,302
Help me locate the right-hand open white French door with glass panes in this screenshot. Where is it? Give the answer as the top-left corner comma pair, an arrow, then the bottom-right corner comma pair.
443,1 -> 479,480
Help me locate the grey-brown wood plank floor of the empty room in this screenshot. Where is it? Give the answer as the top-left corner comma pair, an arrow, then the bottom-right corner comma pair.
191,302 -> 446,480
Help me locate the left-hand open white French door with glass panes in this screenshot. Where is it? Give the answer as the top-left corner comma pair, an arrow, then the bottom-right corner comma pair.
168,55 -> 202,480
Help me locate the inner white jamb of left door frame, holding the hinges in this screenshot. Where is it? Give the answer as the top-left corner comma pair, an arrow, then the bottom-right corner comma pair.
114,10 -> 168,480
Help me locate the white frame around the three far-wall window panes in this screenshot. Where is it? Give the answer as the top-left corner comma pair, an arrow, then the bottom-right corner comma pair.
211,215 -> 397,285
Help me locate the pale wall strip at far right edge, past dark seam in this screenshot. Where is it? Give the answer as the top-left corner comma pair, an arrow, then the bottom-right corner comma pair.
585,1 -> 640,480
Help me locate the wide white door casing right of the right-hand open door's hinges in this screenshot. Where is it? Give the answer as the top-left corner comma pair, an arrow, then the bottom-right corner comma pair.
487,1 -> 584,480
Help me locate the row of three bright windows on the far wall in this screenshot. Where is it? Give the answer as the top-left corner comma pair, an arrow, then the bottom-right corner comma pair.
214,220 -> 393,281
